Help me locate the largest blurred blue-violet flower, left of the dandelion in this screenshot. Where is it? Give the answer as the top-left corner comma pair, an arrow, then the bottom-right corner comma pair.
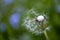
9,13 -> 20,29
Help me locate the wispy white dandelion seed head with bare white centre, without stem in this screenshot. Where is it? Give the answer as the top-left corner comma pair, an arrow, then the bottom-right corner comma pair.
22,9 -> 47,35
